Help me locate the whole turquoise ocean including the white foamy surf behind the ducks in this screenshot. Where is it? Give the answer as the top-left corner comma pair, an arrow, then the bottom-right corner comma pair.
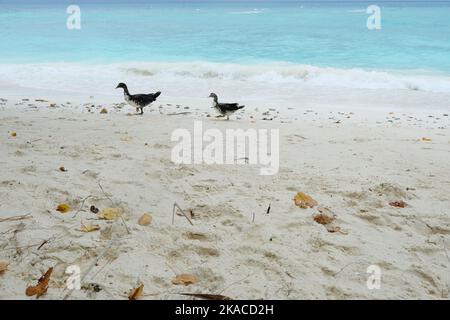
0,0 -> 450,95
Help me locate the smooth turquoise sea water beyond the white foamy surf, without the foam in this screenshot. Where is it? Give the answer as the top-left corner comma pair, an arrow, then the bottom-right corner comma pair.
0,0 -> 450,73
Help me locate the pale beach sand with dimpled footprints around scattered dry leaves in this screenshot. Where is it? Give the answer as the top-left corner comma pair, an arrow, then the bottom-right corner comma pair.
0,98 -> 450,299
